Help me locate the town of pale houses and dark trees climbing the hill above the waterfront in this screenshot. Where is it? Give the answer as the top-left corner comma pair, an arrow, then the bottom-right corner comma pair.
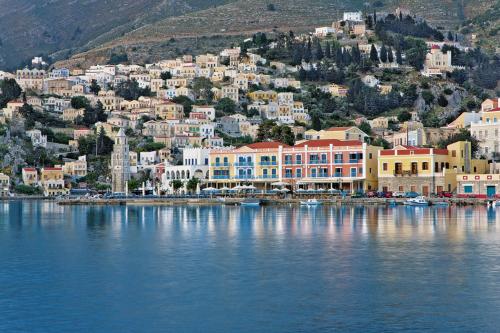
0,9 -> 500,197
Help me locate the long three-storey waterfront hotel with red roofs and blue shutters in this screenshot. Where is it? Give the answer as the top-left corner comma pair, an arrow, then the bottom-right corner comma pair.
209,139 -> 382,192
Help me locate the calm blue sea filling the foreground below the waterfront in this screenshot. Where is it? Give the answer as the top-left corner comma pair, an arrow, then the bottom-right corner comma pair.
0,202 -> 500,332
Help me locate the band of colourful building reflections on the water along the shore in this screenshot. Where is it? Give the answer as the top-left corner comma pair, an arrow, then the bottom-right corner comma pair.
0,201 -> 500,246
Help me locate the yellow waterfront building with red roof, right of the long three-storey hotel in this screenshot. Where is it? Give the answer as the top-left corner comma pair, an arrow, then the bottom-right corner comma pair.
378,141 -> 488,195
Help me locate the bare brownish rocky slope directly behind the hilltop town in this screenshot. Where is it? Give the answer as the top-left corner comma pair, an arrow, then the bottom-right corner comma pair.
54,0 -> 492,67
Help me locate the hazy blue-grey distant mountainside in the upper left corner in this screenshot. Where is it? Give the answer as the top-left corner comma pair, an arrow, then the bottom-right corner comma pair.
0,0 -> 231,69
